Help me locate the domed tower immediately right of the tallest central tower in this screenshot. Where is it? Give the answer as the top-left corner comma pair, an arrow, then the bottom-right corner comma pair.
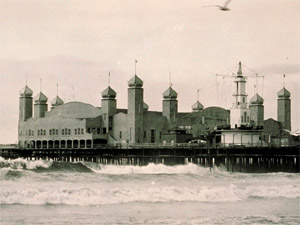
163,86 -> 178,129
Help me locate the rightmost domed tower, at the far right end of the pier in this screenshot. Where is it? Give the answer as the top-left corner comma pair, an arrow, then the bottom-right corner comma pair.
277,87 -> 291,130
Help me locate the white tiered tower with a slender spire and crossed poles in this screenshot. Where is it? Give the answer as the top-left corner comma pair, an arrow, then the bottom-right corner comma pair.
230,62 -> 250,128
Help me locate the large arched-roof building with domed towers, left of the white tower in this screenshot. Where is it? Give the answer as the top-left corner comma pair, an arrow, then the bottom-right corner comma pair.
18,75 -> 230,148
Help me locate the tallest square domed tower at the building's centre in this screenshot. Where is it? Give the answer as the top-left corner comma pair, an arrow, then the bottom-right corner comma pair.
128,75 -> 144,143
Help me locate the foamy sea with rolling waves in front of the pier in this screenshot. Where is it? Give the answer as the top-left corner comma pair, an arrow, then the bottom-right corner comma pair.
0,158 -> 300,225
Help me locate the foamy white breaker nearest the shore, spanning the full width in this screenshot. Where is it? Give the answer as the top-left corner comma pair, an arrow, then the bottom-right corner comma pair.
0,184 -> 300,206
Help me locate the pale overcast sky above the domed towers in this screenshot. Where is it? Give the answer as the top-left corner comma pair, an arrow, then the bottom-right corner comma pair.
0,0 -> 300,143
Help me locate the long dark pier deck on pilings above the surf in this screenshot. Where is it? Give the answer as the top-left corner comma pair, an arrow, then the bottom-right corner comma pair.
0,144 -> 300,173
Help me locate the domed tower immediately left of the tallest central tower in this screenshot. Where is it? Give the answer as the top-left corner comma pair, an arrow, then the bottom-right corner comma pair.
101,86 -> 117,134
